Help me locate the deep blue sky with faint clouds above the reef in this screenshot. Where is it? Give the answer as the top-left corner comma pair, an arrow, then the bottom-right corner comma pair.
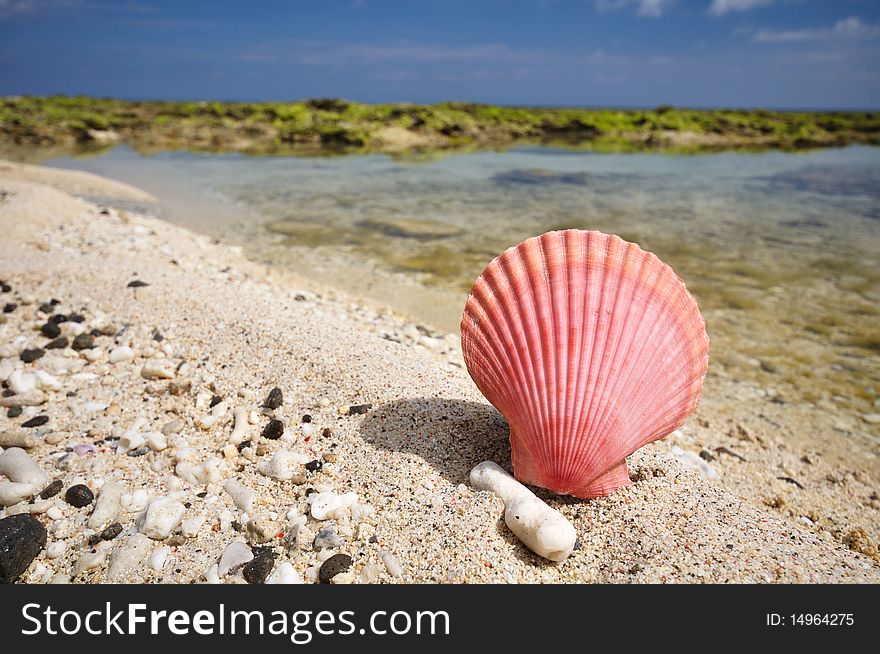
0,0 -> 880,108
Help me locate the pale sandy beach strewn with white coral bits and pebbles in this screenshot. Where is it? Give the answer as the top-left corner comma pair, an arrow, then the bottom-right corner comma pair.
0,163 -> 880,583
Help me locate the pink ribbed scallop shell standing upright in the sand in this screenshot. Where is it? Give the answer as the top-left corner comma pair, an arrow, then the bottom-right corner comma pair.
461,229 -> 709,498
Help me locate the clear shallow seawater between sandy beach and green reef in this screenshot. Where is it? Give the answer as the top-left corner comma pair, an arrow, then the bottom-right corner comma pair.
44,147 -> 880,433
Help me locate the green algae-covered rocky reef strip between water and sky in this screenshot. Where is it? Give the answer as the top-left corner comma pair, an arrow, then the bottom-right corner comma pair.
0,96 -> 880,154
